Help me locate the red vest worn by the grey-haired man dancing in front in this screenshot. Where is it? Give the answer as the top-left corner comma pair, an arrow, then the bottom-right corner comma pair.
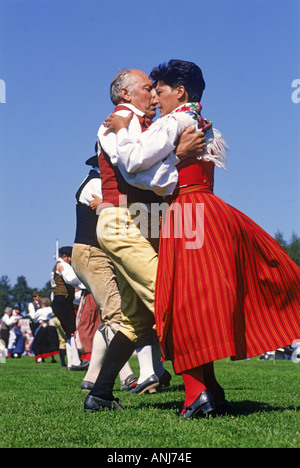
98,105 -> 162,207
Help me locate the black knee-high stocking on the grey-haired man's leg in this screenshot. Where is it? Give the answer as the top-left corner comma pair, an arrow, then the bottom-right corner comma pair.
90,332 -> 135,400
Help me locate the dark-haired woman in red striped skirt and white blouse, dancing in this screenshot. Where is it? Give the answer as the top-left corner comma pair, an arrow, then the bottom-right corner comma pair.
103,60 -> 300,418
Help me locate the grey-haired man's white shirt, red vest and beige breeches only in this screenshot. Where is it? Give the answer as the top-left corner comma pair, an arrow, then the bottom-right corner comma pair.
97,104 -> 161,342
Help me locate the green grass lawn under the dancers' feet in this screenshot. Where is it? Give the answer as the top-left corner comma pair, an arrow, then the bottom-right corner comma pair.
0,357 -> 300,449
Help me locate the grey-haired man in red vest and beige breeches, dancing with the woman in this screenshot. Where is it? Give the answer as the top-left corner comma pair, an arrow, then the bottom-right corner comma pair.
84,70 -> 205,412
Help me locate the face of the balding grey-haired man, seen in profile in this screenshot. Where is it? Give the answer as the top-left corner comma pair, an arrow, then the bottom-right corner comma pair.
130,70 -> 157,119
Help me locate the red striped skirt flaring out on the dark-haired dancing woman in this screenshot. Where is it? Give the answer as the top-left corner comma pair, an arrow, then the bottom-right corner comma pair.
155,186 -> 300,373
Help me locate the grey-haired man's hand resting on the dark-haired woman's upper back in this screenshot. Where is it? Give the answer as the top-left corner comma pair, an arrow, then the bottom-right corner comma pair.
175,127 -> 206,160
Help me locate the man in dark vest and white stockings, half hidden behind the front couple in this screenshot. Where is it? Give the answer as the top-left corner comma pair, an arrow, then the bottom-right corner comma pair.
72,150 -> 137,391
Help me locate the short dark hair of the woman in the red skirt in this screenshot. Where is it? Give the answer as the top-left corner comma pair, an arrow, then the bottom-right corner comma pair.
150,59 -> 205,102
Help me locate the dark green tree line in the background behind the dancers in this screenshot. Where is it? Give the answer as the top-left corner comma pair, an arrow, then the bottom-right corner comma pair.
0,231 -> 300,317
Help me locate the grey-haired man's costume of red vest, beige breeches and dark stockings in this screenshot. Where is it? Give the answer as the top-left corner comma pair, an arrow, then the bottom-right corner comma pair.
85,103 -> 169,408
